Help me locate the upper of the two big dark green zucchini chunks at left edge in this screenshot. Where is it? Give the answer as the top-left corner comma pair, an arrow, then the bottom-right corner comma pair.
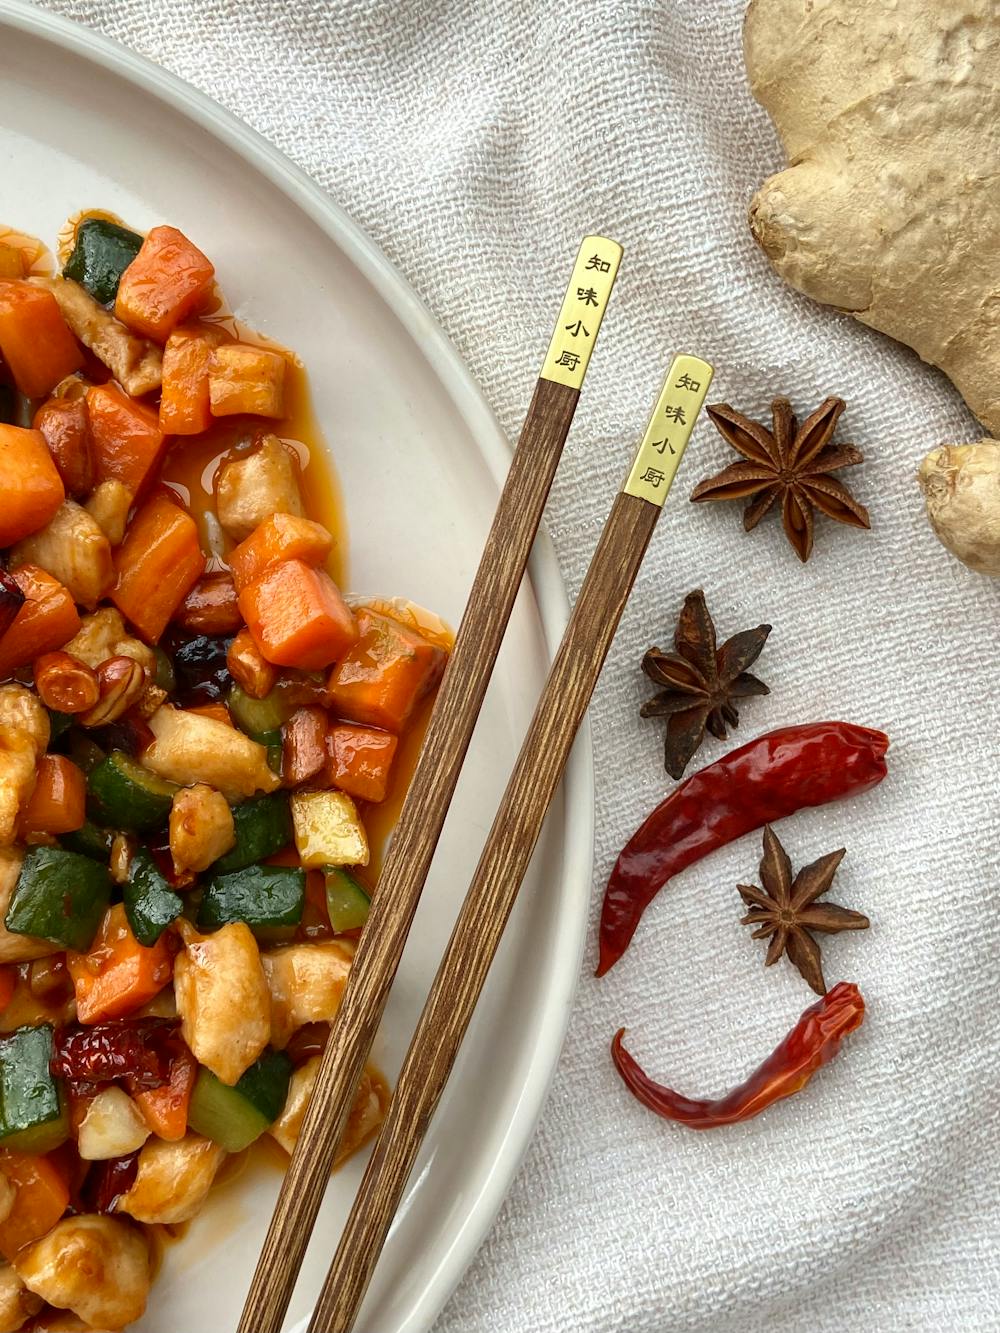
4,846 -> 111,950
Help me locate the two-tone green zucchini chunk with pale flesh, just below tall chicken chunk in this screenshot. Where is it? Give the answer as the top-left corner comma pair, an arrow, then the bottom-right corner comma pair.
188,1050 -> 292,1153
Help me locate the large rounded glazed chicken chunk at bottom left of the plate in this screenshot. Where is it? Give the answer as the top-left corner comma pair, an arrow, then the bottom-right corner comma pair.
15,1213 -> 151,1329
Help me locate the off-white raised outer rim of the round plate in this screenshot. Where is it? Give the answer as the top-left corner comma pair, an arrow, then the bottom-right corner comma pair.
0,0 -> 596,1333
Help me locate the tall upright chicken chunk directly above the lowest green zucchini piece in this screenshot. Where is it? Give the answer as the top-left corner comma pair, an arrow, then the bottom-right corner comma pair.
173,921 -> 271,1085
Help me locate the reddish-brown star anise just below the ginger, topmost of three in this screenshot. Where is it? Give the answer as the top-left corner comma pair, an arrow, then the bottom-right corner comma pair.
691,399 -> 871,561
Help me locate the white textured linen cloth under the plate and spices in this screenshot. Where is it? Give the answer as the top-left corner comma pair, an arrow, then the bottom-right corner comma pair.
31,0 -> 1000,1333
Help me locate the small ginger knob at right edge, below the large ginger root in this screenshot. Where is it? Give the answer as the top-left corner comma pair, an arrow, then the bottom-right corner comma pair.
917,440 -> 1000,579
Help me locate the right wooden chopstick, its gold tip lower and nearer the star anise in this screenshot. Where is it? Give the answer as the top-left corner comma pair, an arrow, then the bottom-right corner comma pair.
309,356 -> 712,1333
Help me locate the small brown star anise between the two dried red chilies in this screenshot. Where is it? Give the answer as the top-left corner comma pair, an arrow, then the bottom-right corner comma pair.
737,825 -> 868,996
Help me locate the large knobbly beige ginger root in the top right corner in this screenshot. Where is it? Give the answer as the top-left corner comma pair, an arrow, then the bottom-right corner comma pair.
744,0 -> 1000,435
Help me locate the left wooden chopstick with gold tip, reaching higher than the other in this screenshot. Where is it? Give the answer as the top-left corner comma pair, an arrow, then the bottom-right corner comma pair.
239,236 -> 621,1333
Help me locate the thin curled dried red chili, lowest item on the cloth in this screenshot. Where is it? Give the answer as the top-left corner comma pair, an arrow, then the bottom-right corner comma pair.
611,981 -> 864,1129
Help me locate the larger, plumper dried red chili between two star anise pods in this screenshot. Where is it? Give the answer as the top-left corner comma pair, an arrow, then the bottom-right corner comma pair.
597,722 -> 889,977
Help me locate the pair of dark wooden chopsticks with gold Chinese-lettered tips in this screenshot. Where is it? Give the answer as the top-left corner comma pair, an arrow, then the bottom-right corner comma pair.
239,236 -> 712,1333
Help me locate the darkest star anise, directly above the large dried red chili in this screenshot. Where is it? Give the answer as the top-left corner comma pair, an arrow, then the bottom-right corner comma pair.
640,588 -> 771,778
